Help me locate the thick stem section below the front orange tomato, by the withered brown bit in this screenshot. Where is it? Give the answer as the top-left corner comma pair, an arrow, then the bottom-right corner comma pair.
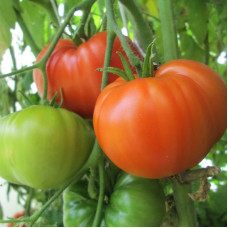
172,179 -> 197,227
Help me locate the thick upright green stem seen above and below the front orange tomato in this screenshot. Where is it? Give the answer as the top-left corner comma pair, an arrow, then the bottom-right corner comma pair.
158,0 -> 197,226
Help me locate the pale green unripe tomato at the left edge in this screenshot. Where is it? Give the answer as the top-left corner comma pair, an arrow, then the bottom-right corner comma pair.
0,106 -> 94,189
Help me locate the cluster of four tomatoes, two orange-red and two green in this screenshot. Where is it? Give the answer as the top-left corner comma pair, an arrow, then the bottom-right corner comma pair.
0,31 -> 227,227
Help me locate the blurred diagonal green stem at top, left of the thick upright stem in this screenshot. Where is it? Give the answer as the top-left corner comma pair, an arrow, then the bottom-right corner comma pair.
119,0 -> 153,52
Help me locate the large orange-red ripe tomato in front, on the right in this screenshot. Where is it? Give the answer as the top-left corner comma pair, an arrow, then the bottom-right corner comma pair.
93,60 -> 227,178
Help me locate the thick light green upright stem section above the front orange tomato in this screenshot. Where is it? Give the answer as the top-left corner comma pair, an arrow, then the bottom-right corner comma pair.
158,0 -> 179,62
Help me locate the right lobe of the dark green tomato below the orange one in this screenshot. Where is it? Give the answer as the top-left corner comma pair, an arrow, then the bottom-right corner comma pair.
105,174 -> 165,227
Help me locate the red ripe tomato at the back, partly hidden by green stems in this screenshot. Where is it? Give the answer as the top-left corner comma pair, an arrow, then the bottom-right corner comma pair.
33,31 -> 140,118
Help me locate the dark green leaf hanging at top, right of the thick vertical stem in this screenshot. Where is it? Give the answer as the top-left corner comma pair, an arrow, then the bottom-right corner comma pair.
184,0 -> 208,45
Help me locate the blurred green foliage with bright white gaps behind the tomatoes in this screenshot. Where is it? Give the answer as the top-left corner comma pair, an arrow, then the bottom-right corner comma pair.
0,0 -> 227,226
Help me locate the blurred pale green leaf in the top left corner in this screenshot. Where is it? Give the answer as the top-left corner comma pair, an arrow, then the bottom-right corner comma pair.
0,0 -> 16,58
